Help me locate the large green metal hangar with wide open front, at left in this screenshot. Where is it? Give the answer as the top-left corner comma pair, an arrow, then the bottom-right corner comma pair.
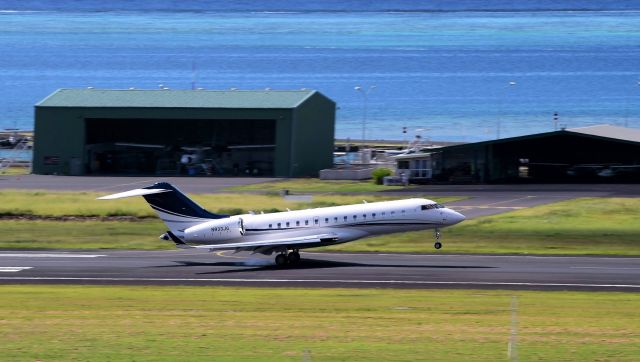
33,89 -> 336,177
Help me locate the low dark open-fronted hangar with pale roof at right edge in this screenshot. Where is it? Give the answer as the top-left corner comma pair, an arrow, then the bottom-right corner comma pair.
428,125 -> 640,183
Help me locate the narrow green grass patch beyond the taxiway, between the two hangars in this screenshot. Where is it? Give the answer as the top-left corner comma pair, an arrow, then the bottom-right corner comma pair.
226,178 -> 410,192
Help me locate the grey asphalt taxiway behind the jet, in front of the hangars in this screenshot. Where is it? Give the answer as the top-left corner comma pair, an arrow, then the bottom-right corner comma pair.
0,175 -> 640,219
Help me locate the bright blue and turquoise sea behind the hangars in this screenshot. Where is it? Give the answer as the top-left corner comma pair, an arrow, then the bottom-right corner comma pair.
0,0 -> 640,141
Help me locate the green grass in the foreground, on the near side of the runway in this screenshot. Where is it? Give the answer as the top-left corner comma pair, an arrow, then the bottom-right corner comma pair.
0,285 -> 640,361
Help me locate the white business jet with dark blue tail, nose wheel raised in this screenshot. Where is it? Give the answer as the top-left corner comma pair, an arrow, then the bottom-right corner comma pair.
98,182 -> 465,267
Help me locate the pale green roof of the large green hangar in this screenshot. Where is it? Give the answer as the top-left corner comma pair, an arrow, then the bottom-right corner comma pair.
36,89 -> 319,109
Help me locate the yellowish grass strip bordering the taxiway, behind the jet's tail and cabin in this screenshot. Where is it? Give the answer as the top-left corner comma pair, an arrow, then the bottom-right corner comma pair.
0,190 -> 461,217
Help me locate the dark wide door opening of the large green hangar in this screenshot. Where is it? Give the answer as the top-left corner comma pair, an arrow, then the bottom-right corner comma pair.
85,118 -> 276,176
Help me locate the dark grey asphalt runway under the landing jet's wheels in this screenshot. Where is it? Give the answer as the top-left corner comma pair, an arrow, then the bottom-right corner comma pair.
0,250 -> 640,292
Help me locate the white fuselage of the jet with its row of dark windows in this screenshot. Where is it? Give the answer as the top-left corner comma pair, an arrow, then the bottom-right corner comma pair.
181,199 -> 464,249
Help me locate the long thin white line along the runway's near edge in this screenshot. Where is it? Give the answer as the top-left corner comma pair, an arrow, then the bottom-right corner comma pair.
0,277 -> 640,289
